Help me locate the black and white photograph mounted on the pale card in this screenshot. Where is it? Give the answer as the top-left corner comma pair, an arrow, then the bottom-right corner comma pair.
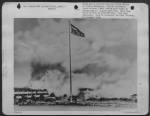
13,18 -> 138,111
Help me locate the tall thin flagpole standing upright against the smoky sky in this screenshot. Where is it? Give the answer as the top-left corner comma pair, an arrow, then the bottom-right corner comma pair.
69,20 -> 72,103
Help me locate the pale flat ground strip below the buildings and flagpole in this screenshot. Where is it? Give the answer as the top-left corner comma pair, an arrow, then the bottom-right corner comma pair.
14,101 -> 137,111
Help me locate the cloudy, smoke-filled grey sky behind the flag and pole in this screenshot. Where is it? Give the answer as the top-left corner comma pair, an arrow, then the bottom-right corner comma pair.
14,18 -> 137,97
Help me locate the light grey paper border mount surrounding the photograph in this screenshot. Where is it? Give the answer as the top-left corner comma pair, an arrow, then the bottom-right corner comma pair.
2,2 -> 149,115
